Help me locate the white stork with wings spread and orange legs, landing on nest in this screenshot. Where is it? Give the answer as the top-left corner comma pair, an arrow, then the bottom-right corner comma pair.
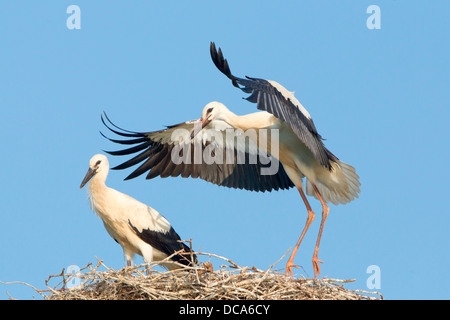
102,43 -> 360,278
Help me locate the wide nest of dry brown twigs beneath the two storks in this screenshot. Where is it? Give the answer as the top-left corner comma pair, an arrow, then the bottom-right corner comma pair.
35,253 -> 383,300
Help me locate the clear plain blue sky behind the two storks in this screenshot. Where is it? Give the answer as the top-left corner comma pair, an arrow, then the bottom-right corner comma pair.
0,0 -> 450,299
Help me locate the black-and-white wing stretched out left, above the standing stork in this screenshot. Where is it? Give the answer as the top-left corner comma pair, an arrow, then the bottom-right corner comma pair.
102,114 -> 294,192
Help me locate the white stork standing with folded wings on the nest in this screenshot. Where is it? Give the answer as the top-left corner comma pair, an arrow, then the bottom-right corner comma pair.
80,154 -> 196,270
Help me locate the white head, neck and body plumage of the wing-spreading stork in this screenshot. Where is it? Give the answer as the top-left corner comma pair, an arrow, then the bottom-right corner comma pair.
201,101 -> 360,204
